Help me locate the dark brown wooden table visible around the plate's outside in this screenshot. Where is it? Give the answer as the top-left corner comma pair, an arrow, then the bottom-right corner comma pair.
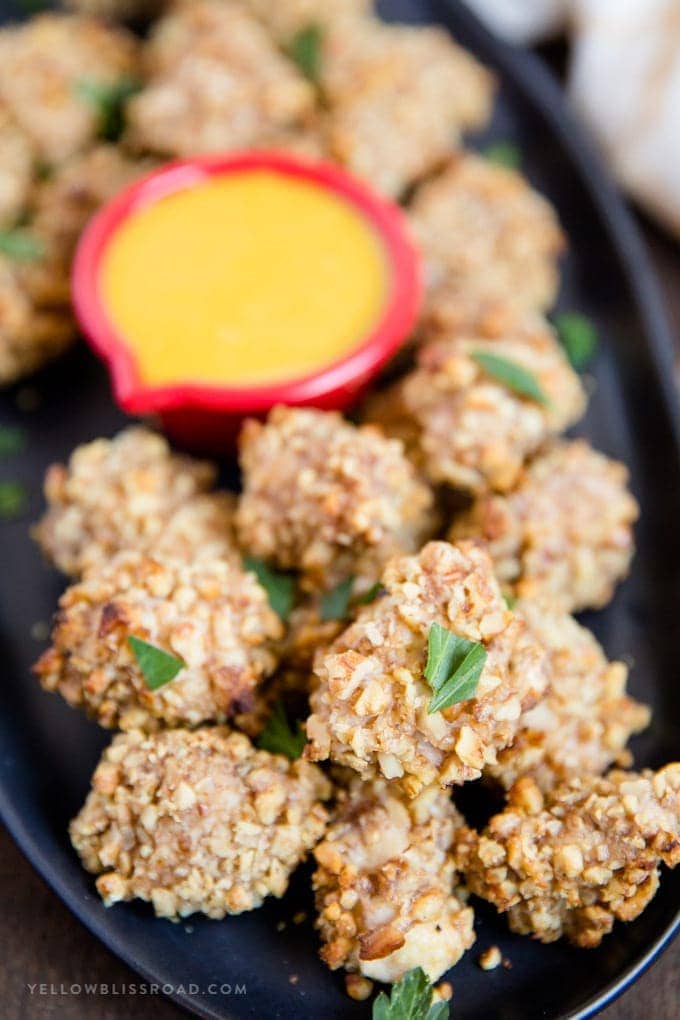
0,213 -> 680,1020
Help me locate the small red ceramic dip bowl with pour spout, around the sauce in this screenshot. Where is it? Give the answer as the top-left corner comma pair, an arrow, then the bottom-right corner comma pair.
72,152 -> 422,450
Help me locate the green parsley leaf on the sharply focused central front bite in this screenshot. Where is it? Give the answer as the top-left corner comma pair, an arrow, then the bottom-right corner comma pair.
425,623 -> 486,713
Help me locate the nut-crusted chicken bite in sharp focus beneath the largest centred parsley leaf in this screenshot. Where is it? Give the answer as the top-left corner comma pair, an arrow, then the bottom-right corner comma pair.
307,542 -> 546,796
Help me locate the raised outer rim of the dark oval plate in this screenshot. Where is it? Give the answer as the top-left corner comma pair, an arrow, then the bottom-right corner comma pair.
0,0 -> 680,1020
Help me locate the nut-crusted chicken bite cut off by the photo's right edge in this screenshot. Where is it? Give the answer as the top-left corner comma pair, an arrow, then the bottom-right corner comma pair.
457,763 -> 680,949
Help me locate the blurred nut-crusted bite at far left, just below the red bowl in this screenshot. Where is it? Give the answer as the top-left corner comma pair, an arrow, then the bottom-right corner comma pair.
34,427 -> 232,576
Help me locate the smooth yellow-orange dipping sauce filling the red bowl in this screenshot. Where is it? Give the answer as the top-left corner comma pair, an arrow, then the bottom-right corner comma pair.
100,169 -> 388,387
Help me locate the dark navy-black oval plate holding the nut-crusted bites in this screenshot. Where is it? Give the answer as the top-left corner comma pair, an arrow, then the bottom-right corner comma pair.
0,0 -> 680,1020
